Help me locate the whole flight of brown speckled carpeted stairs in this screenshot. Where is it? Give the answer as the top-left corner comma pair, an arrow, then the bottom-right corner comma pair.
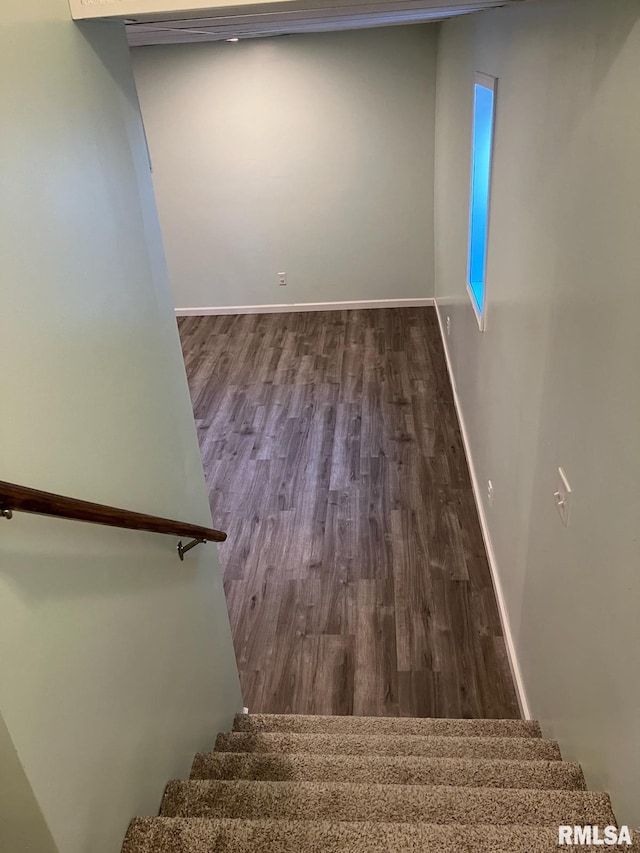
122,714 -> 636,853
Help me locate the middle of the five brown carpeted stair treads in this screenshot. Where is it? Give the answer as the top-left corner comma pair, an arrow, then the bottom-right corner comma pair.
191,752 -> 585,790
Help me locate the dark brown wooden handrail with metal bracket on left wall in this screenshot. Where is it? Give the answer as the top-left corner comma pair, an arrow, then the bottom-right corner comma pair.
0,480 -> 227,559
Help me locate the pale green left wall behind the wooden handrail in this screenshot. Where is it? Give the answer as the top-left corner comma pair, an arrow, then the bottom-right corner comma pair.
0,0 -> 241,853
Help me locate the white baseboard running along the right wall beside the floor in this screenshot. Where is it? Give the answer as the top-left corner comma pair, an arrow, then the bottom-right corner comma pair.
434,299 -> 532,720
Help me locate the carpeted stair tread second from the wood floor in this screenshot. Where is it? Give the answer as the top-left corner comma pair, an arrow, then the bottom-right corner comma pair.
215,732 -> 561,760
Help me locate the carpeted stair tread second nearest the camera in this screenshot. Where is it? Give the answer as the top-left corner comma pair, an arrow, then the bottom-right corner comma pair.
160,780 -> 615,827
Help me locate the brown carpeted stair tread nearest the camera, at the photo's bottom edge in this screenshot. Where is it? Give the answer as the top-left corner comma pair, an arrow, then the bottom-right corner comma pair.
122,817 -> 639,853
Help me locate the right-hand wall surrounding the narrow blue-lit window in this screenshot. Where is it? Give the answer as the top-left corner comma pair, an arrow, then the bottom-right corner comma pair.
436,0 -> 640,825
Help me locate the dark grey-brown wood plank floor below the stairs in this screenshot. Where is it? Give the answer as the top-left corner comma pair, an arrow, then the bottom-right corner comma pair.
179,308 -> 519,717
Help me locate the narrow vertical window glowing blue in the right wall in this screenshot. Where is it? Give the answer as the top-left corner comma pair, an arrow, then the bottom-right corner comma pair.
467,74 -> 497,330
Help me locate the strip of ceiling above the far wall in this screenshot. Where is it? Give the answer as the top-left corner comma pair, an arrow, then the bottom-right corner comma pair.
127,0 -> 524,47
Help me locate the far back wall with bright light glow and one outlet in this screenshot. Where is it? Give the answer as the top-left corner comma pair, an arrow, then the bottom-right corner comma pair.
132,25 -> 437,308
